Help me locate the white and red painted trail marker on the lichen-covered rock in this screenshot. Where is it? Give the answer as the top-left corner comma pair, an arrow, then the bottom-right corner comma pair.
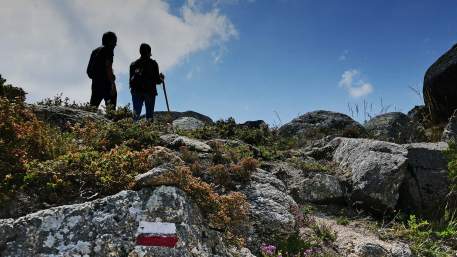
136,221 -> 178,248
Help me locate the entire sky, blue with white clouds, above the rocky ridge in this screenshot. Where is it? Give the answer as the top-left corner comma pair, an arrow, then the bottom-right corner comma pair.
0,0 -> 457,126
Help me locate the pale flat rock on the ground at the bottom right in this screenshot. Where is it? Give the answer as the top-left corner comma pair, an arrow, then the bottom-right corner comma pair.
313,215 -> 413,257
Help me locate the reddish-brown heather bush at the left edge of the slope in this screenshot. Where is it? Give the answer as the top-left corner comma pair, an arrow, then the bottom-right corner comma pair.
0,97 -> 73,181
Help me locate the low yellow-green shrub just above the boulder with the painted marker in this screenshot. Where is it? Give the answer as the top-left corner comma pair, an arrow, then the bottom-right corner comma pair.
23,146 -> 152,203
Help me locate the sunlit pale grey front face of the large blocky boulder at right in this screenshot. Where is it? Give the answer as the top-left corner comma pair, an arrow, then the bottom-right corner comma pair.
333,138 -> 407,213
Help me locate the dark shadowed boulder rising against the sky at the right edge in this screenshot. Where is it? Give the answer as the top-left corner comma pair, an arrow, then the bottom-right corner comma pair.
423,45 -> 457,123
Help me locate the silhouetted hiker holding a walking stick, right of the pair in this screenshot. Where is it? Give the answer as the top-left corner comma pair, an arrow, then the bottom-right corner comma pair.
129,43 -> 165,121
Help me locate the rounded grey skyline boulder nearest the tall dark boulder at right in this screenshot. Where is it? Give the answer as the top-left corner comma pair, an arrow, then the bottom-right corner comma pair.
365,112 -> 425,144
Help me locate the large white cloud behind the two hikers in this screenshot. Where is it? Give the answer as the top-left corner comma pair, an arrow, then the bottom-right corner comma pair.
0,0 -> 238,101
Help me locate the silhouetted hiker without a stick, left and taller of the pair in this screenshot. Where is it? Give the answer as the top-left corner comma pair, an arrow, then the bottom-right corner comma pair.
87,31 -> 117,109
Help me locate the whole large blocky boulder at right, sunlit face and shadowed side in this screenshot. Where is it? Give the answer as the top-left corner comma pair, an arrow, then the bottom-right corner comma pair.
320,138 -> 450,217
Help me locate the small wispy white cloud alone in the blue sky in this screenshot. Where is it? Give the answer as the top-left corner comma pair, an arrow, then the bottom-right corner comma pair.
339,69 -> 374,97
